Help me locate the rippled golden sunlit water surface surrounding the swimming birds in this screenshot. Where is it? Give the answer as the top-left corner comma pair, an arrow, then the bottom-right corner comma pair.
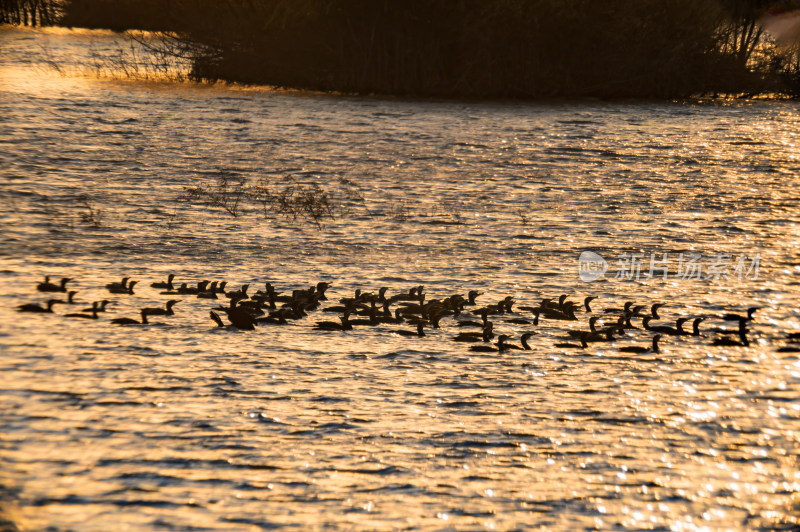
0,28 -> 800,531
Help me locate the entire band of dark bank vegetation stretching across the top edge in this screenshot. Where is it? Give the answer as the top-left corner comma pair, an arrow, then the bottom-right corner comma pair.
3,0 -> 800,98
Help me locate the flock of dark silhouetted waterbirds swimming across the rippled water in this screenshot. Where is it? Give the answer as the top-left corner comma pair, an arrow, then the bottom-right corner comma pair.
17,274 -> 800,353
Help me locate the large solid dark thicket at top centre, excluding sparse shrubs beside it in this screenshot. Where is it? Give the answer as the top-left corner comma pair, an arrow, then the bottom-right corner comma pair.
172,0 -> 736,97
